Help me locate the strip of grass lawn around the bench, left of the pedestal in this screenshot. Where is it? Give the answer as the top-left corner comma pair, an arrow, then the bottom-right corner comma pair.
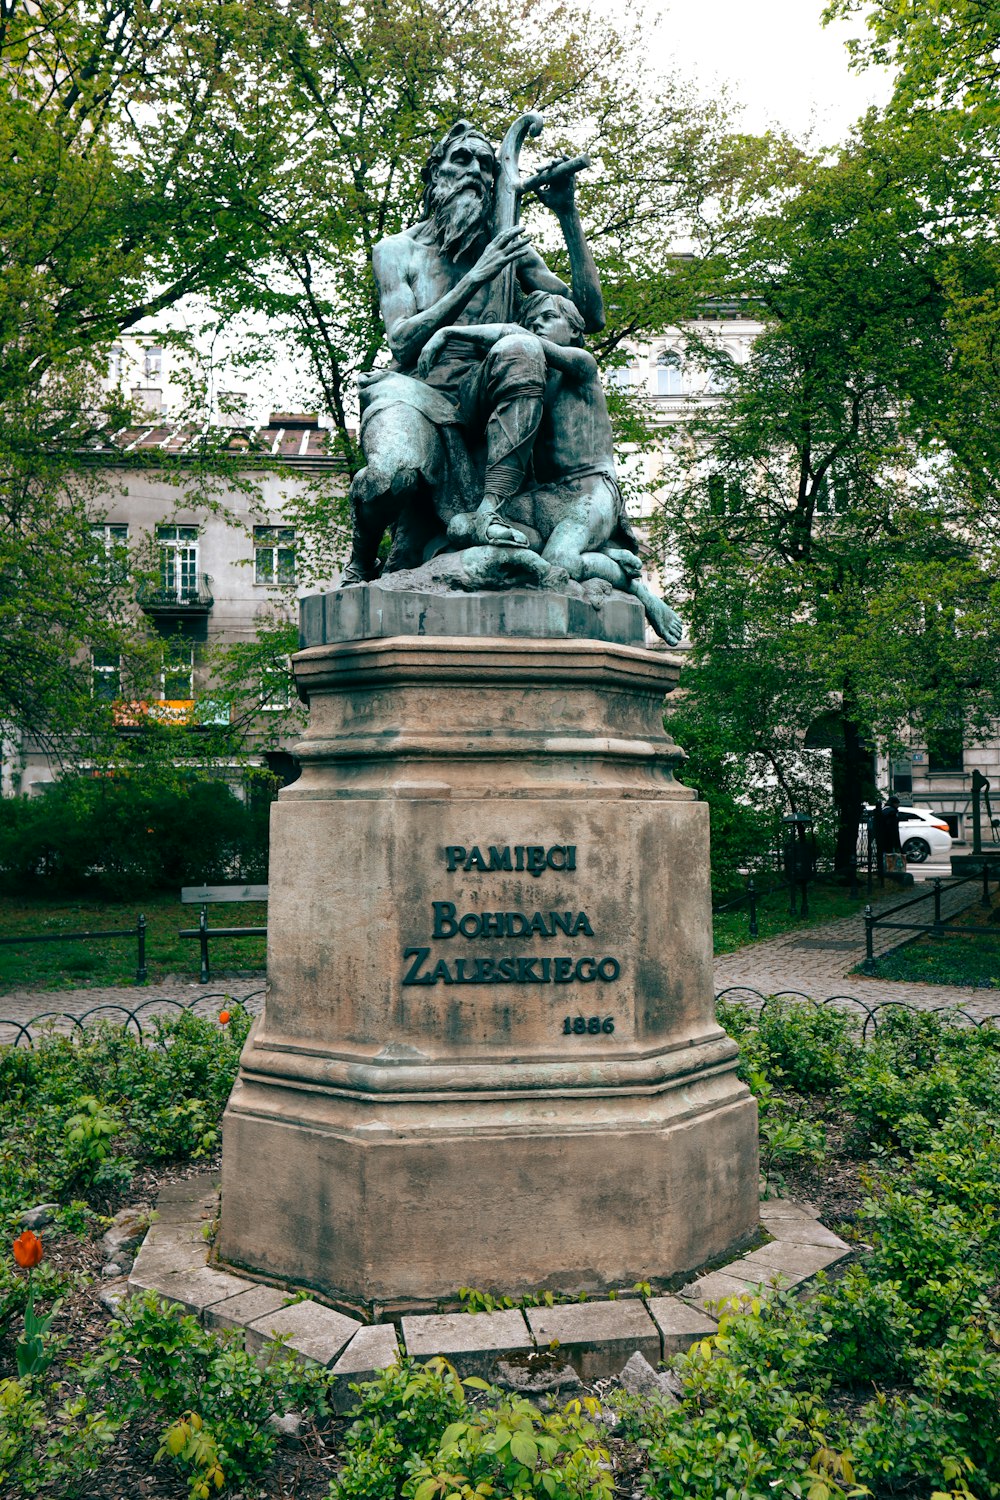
0,896 -> 267,995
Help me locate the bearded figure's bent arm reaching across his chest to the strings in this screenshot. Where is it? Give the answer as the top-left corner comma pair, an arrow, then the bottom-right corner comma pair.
372,225 -> 529,371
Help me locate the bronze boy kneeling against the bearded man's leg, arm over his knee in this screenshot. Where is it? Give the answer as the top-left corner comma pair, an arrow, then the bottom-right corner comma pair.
421,291 -> 682,645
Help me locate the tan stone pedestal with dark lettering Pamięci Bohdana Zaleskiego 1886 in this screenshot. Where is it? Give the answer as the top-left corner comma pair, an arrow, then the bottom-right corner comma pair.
219,587 -> 757,1304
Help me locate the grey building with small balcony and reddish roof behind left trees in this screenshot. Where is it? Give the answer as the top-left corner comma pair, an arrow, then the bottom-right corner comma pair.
3,413 -> 345,794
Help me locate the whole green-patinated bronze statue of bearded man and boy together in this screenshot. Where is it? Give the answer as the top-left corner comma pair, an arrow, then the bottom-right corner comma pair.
343,114 -> 682,644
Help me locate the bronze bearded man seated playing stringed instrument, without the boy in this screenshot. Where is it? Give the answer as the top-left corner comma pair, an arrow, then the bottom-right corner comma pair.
342,120 -> 604,584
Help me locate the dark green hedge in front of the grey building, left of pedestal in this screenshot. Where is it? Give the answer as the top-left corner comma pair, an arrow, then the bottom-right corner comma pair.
0,774 -> 277,899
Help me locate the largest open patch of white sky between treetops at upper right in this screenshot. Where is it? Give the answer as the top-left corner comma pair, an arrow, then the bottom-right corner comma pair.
602,0 -> 889,144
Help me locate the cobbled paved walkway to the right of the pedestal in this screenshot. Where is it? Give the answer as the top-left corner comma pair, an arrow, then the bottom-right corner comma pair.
715,884 -> 1000,1017
